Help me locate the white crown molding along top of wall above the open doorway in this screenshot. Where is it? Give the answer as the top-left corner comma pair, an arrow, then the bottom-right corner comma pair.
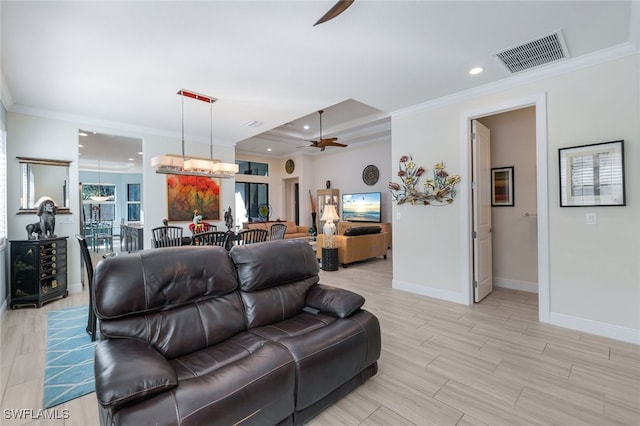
390,42 -> 640,117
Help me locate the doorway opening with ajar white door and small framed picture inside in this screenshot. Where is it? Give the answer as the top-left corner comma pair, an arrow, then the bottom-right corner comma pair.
471,106 -> 538,302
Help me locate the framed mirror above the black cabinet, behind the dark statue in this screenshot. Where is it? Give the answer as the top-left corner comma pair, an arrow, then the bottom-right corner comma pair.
16,157 -> 71,214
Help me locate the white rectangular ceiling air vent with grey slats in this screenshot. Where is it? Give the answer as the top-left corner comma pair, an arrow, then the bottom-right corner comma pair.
494,31 -> 569,73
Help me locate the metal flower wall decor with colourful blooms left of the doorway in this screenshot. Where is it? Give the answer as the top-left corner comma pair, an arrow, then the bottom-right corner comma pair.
389,154 -> 460,206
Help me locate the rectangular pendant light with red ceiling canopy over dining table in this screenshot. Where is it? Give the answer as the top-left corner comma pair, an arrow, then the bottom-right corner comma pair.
151,89 -> 239,179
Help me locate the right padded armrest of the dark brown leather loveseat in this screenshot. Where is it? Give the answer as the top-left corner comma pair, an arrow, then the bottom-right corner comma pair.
307,284 -> 364,318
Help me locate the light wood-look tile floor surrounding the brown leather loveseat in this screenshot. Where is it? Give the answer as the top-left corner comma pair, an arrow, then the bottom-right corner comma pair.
0,255 -> 640,426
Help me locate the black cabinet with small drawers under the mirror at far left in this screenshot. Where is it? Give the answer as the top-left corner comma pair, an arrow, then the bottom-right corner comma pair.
10,237 -> 69,309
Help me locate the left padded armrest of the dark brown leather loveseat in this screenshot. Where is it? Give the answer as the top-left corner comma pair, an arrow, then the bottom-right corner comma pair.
94,339 -> 178,408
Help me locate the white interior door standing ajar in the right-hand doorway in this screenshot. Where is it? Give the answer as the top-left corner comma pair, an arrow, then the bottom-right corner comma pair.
471,120 -> 493,302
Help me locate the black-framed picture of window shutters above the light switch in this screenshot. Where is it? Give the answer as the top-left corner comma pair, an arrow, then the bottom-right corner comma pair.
558,140 -> 625,207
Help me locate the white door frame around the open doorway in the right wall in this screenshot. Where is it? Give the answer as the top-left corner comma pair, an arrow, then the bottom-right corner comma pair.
459,92 -> 550,323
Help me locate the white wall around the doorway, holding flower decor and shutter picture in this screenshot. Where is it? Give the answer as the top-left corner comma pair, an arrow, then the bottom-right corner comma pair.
392,54 -> 640,343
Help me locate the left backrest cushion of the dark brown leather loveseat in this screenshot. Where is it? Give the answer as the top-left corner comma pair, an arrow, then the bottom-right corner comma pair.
94,246 -> 246,358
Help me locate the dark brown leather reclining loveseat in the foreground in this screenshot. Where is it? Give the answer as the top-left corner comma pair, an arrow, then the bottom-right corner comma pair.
94,240 -> 381,425
